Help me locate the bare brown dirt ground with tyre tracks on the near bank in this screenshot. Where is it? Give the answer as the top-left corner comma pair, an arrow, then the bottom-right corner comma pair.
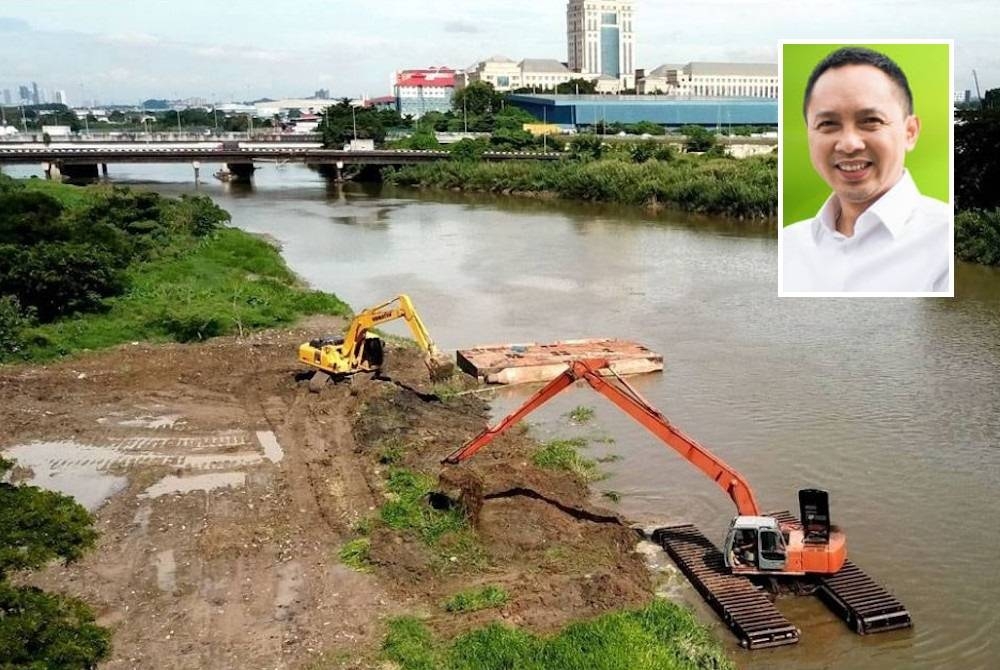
0,318 -> 651,670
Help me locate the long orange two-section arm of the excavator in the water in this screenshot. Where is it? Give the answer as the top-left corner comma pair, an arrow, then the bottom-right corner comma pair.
443,359 -> 760,516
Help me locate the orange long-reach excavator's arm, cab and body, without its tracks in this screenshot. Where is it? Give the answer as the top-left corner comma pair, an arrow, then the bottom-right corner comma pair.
443,359 -> 847,576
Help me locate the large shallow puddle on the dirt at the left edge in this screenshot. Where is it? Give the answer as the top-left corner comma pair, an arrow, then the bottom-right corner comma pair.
4,441 -> 128,512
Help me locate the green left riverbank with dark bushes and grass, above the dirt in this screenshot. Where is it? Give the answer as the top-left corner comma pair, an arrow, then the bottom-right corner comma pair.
0,179 -> 349,362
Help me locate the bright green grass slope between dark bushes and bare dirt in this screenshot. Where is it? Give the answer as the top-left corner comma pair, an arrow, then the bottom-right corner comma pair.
19,228 -> 349,360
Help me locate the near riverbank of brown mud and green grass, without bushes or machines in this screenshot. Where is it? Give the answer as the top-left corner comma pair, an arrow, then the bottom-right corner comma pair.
0,178 -> 731,668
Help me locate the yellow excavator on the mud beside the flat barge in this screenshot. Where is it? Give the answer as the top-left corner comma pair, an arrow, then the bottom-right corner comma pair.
299,294 -> 454,393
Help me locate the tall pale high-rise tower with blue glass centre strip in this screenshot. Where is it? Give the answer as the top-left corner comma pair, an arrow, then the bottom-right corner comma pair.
566,0 -> 635,79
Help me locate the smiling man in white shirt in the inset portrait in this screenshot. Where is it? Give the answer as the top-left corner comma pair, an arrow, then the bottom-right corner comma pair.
781,47 -> 952,295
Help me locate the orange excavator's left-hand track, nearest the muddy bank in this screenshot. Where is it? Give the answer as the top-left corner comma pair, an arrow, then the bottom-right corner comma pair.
653,524 -> 799,649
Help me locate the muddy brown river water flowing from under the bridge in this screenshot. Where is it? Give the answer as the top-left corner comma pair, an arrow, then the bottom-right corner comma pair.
10,165 -> 1000,668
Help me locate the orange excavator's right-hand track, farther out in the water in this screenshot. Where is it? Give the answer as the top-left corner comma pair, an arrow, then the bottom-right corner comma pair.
770,511 -> 913,635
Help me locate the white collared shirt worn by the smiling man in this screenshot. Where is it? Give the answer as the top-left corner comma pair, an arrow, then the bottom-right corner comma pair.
781,170 -> 952,293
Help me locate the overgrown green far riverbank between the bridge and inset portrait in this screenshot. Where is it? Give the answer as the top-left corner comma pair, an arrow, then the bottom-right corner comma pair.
383,155 -> 778,219
